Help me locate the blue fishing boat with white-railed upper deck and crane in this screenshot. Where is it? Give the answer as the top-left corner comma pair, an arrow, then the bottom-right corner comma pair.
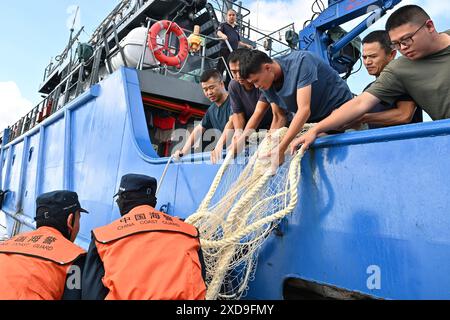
0,0 -> 450,299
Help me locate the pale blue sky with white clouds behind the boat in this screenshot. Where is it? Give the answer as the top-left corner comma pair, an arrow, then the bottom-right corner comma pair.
0,0 -> 450,130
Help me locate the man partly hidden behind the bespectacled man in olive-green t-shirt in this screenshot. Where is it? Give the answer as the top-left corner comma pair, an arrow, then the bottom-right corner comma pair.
346,30 -> 422,129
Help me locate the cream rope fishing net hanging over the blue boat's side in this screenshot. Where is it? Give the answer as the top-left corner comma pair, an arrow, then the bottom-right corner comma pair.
186,125 -> 310,299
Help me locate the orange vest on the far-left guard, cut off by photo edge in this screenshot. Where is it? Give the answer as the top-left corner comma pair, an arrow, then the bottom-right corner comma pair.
0,227 -> 85,300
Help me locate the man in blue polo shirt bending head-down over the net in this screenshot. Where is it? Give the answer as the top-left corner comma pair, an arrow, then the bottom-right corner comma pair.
240,50 -> 353,167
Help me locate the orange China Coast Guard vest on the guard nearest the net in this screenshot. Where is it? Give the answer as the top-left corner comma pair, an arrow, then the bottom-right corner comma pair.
93,206 -> 206,300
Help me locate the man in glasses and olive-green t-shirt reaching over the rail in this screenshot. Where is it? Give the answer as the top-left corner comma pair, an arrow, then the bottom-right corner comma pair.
291,5 -> 450,152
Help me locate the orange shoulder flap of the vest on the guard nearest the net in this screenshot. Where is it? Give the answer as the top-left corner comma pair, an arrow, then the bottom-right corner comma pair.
92,206 -> 198,243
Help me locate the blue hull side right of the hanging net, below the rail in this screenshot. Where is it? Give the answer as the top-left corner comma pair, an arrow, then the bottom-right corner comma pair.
250,131 -> 450,299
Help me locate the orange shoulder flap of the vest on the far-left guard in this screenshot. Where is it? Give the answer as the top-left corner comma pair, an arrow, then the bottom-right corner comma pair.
0,227 -> 85,265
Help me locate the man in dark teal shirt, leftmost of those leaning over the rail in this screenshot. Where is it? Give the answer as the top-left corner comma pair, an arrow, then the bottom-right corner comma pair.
174,69 -> 233,158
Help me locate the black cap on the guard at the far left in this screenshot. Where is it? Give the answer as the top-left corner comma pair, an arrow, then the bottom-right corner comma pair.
34,190 -> 89,220
